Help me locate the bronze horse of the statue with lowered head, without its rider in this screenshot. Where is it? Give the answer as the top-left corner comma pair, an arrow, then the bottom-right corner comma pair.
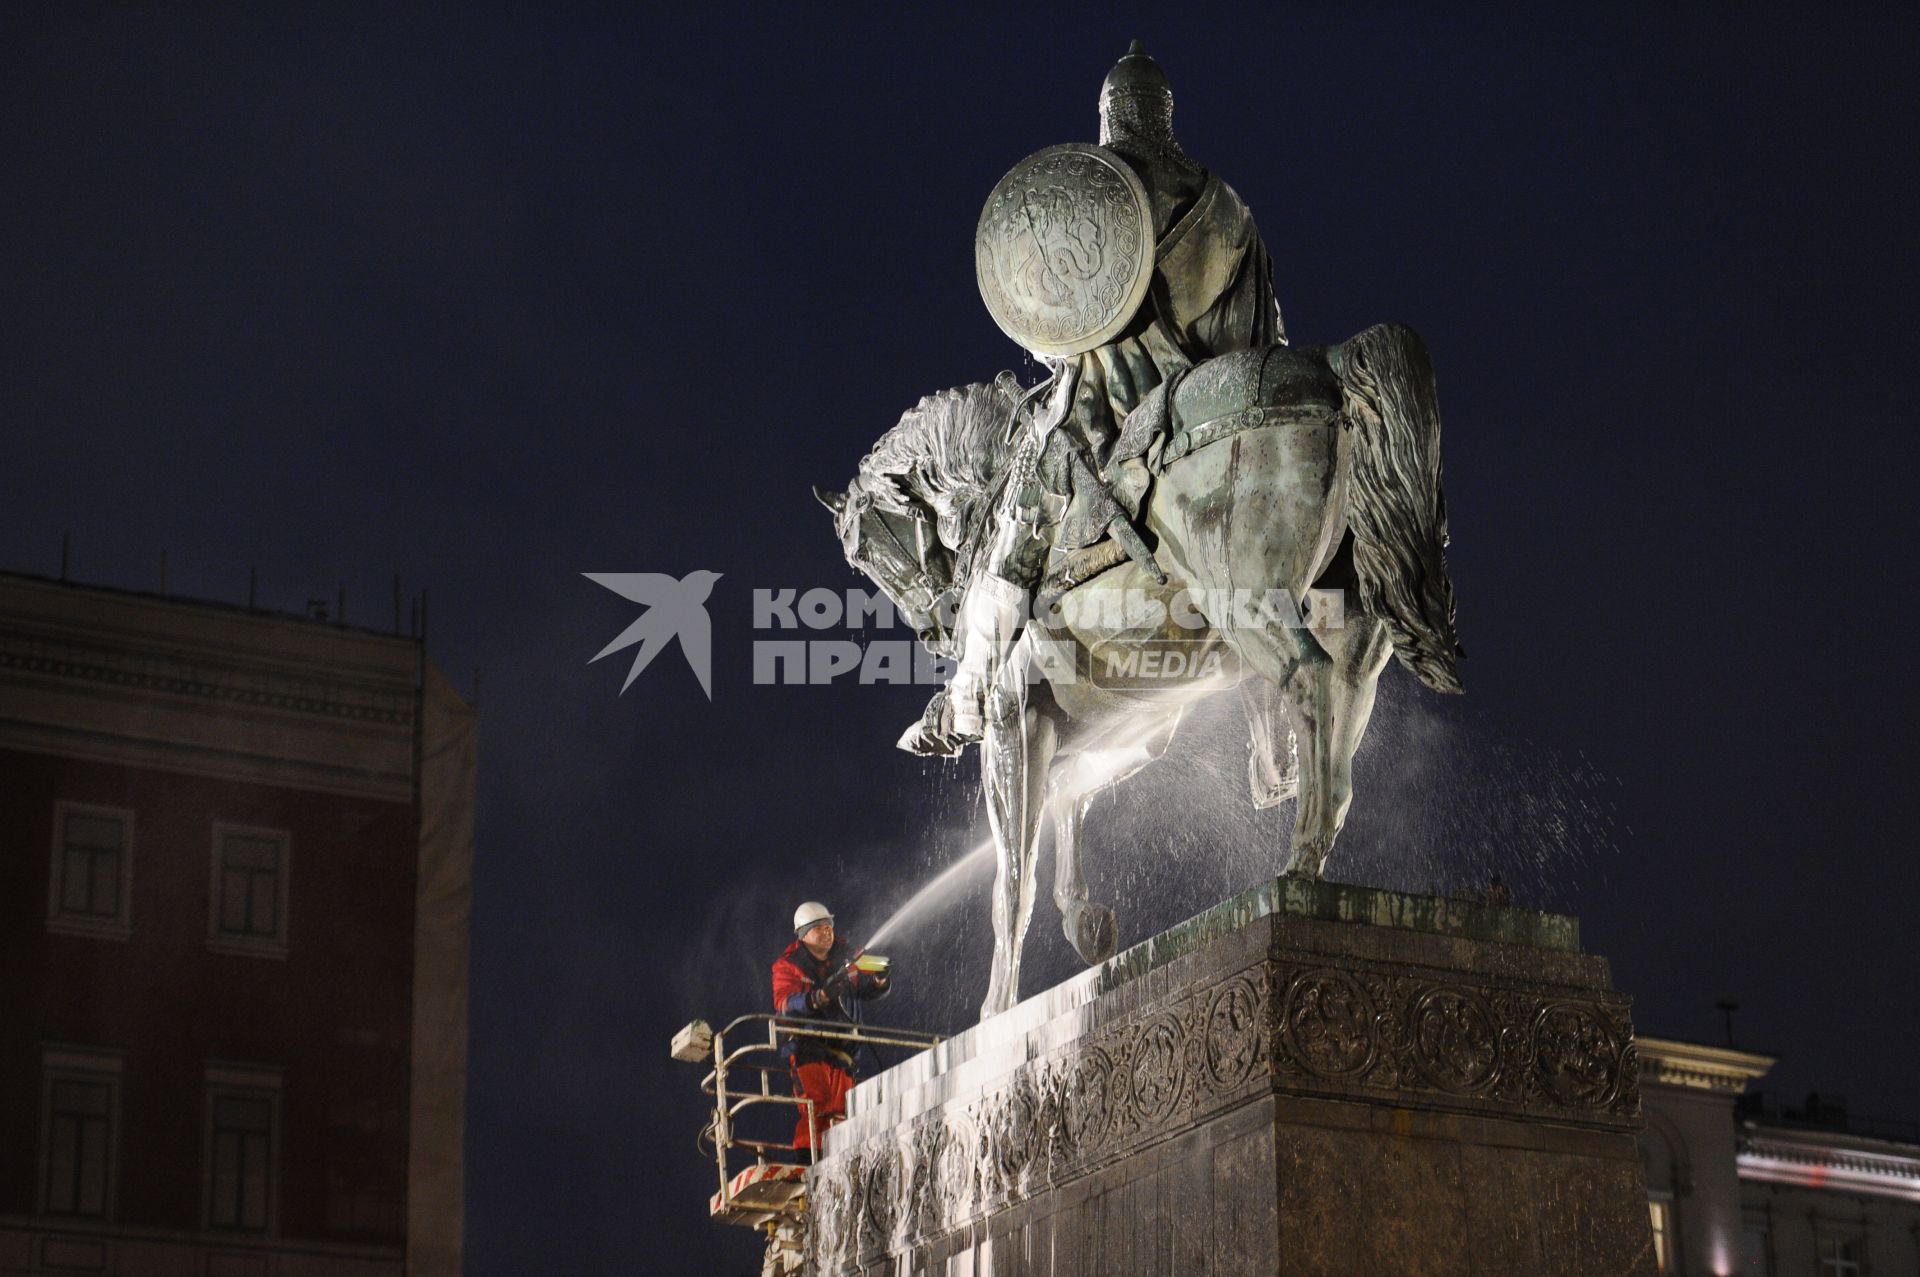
820,325 -> 1463,1018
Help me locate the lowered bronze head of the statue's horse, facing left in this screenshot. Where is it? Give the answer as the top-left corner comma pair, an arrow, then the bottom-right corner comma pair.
814,474 -> 954,655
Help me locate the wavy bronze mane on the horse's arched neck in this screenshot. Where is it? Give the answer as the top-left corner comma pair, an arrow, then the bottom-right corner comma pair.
860,373 -> 1021,515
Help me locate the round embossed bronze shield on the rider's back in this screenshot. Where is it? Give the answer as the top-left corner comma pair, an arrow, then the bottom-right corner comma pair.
973,142 -> 1154,357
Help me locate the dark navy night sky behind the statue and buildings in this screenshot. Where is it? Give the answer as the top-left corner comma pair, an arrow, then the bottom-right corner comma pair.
0,4 -> 1920,1277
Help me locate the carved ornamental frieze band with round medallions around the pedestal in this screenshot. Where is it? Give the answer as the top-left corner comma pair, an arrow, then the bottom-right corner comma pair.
810,962 -> 1640,1273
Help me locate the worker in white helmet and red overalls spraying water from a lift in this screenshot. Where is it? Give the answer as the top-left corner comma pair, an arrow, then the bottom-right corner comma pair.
774,901 -> 891,1148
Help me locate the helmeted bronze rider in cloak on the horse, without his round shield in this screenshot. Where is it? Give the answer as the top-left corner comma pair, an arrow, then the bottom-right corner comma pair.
900,40 -> 1286,753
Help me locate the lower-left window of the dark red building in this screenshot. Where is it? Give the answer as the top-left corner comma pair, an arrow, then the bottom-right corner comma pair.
40,1047 -> 123,1219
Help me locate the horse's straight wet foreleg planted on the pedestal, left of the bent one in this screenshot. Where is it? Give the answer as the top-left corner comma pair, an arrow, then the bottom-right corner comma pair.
979,683 -> 1058,1020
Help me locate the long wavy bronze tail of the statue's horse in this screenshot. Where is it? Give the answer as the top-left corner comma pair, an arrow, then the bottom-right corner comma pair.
1329,325 -> 1465,691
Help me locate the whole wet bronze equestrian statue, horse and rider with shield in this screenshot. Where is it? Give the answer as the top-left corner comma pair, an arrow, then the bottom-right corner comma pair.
820,46 -> 1461,1016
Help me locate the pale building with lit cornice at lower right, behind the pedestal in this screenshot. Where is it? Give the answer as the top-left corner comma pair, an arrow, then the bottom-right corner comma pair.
1640,1037 -> 1920,1277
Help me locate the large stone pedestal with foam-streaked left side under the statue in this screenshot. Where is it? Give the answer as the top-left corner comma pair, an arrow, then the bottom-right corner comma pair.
808,879 -> 1653,1277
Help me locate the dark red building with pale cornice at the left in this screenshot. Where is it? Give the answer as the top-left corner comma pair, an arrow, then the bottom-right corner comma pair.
0,574 -> 476,1277
